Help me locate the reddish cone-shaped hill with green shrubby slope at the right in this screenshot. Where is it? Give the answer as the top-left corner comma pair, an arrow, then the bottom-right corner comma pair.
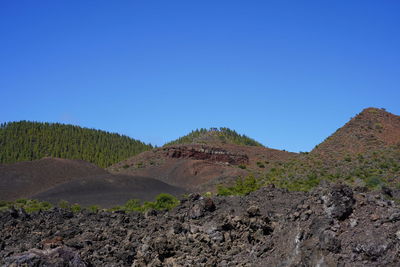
264,108 -> 400,190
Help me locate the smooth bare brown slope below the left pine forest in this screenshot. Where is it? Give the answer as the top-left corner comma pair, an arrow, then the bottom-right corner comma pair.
0,158 -> 107,200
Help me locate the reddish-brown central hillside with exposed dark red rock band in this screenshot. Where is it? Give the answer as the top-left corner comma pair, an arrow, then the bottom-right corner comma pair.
108,143 -> 296,191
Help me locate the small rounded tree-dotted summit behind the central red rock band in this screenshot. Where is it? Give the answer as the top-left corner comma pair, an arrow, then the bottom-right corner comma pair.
165,127 -> 263,146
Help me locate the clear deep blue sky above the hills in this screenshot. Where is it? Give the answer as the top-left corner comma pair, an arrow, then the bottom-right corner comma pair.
0,0 -> 400,151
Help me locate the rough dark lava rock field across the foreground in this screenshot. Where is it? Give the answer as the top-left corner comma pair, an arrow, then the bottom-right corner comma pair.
0,185 -> 400,266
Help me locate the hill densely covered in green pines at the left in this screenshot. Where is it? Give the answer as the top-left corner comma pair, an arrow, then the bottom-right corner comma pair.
0,121 -> 152,167
